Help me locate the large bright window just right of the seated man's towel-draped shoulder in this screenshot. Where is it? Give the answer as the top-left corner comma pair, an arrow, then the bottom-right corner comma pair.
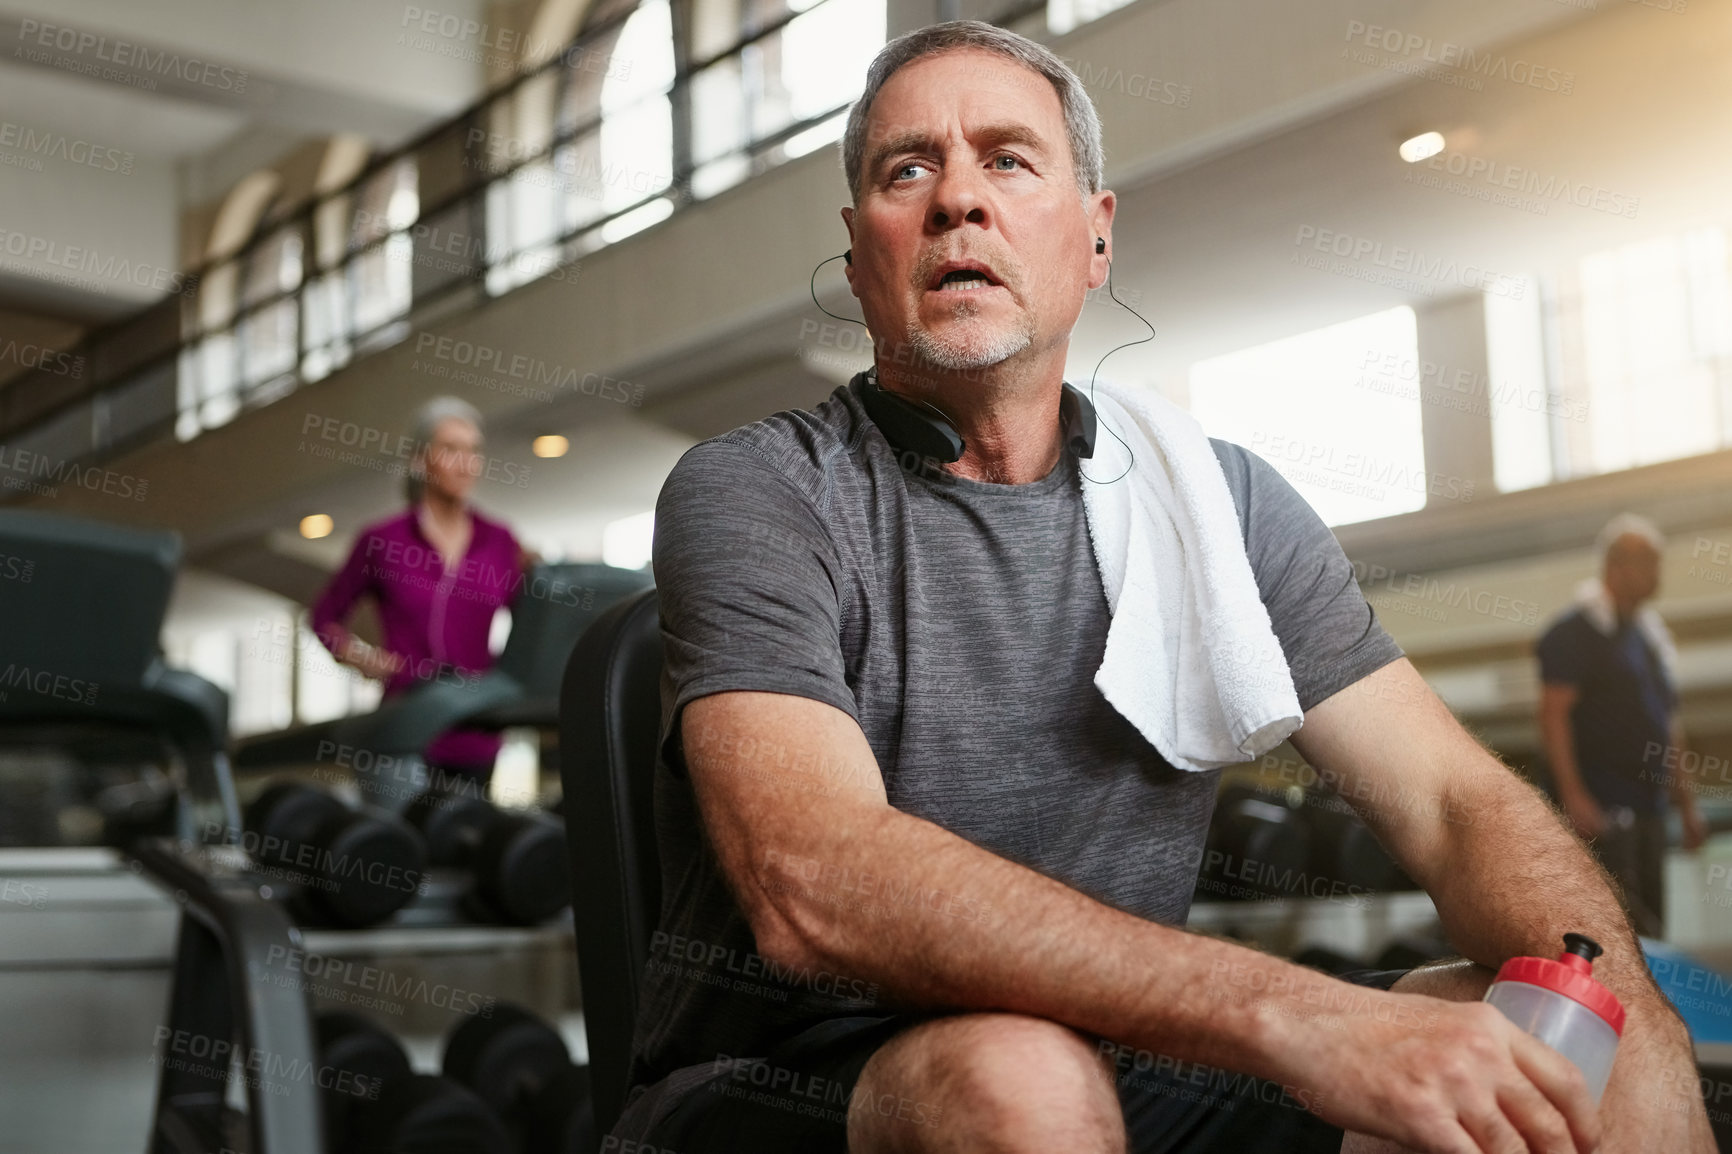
1190,307 -> 1429,525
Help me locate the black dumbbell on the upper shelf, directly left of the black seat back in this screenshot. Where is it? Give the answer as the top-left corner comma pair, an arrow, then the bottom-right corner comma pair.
404,792 -> 572,925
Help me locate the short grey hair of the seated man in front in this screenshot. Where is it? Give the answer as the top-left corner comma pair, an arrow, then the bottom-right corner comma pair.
842,21 -> 1105,208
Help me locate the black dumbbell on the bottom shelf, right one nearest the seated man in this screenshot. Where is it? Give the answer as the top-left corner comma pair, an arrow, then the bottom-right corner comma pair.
443,1002 -> 596,1154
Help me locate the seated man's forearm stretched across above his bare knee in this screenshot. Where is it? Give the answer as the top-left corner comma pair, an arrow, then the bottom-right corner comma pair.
759,786 -> 1346,1076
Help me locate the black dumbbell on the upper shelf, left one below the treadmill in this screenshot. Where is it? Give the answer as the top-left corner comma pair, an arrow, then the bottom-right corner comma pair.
242,781 -> 426,929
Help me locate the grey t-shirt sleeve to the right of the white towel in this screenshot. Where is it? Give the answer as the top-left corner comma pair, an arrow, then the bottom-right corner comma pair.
1223,445 -> 1405,710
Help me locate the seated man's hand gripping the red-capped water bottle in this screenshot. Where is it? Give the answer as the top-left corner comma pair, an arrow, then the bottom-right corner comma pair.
1296,991 -> 1593,1154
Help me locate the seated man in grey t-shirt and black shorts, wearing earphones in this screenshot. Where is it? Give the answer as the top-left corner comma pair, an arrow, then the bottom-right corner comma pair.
611,23 -> 1713,1154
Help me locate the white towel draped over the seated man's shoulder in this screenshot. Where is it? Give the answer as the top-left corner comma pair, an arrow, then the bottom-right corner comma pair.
1081,383 -> 1304,771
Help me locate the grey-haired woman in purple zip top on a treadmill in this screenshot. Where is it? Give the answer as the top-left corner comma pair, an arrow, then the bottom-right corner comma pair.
312,397 -> 535,794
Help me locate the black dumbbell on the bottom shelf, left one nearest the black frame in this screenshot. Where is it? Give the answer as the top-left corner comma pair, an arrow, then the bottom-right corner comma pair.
317,1012 -> 511,1154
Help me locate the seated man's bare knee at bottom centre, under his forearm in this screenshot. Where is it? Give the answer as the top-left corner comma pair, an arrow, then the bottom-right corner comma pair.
849,1014 -> 1124,1154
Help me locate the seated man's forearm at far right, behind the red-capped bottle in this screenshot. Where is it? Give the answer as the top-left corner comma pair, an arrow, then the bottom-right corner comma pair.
1429,755 -> 1677,1022
